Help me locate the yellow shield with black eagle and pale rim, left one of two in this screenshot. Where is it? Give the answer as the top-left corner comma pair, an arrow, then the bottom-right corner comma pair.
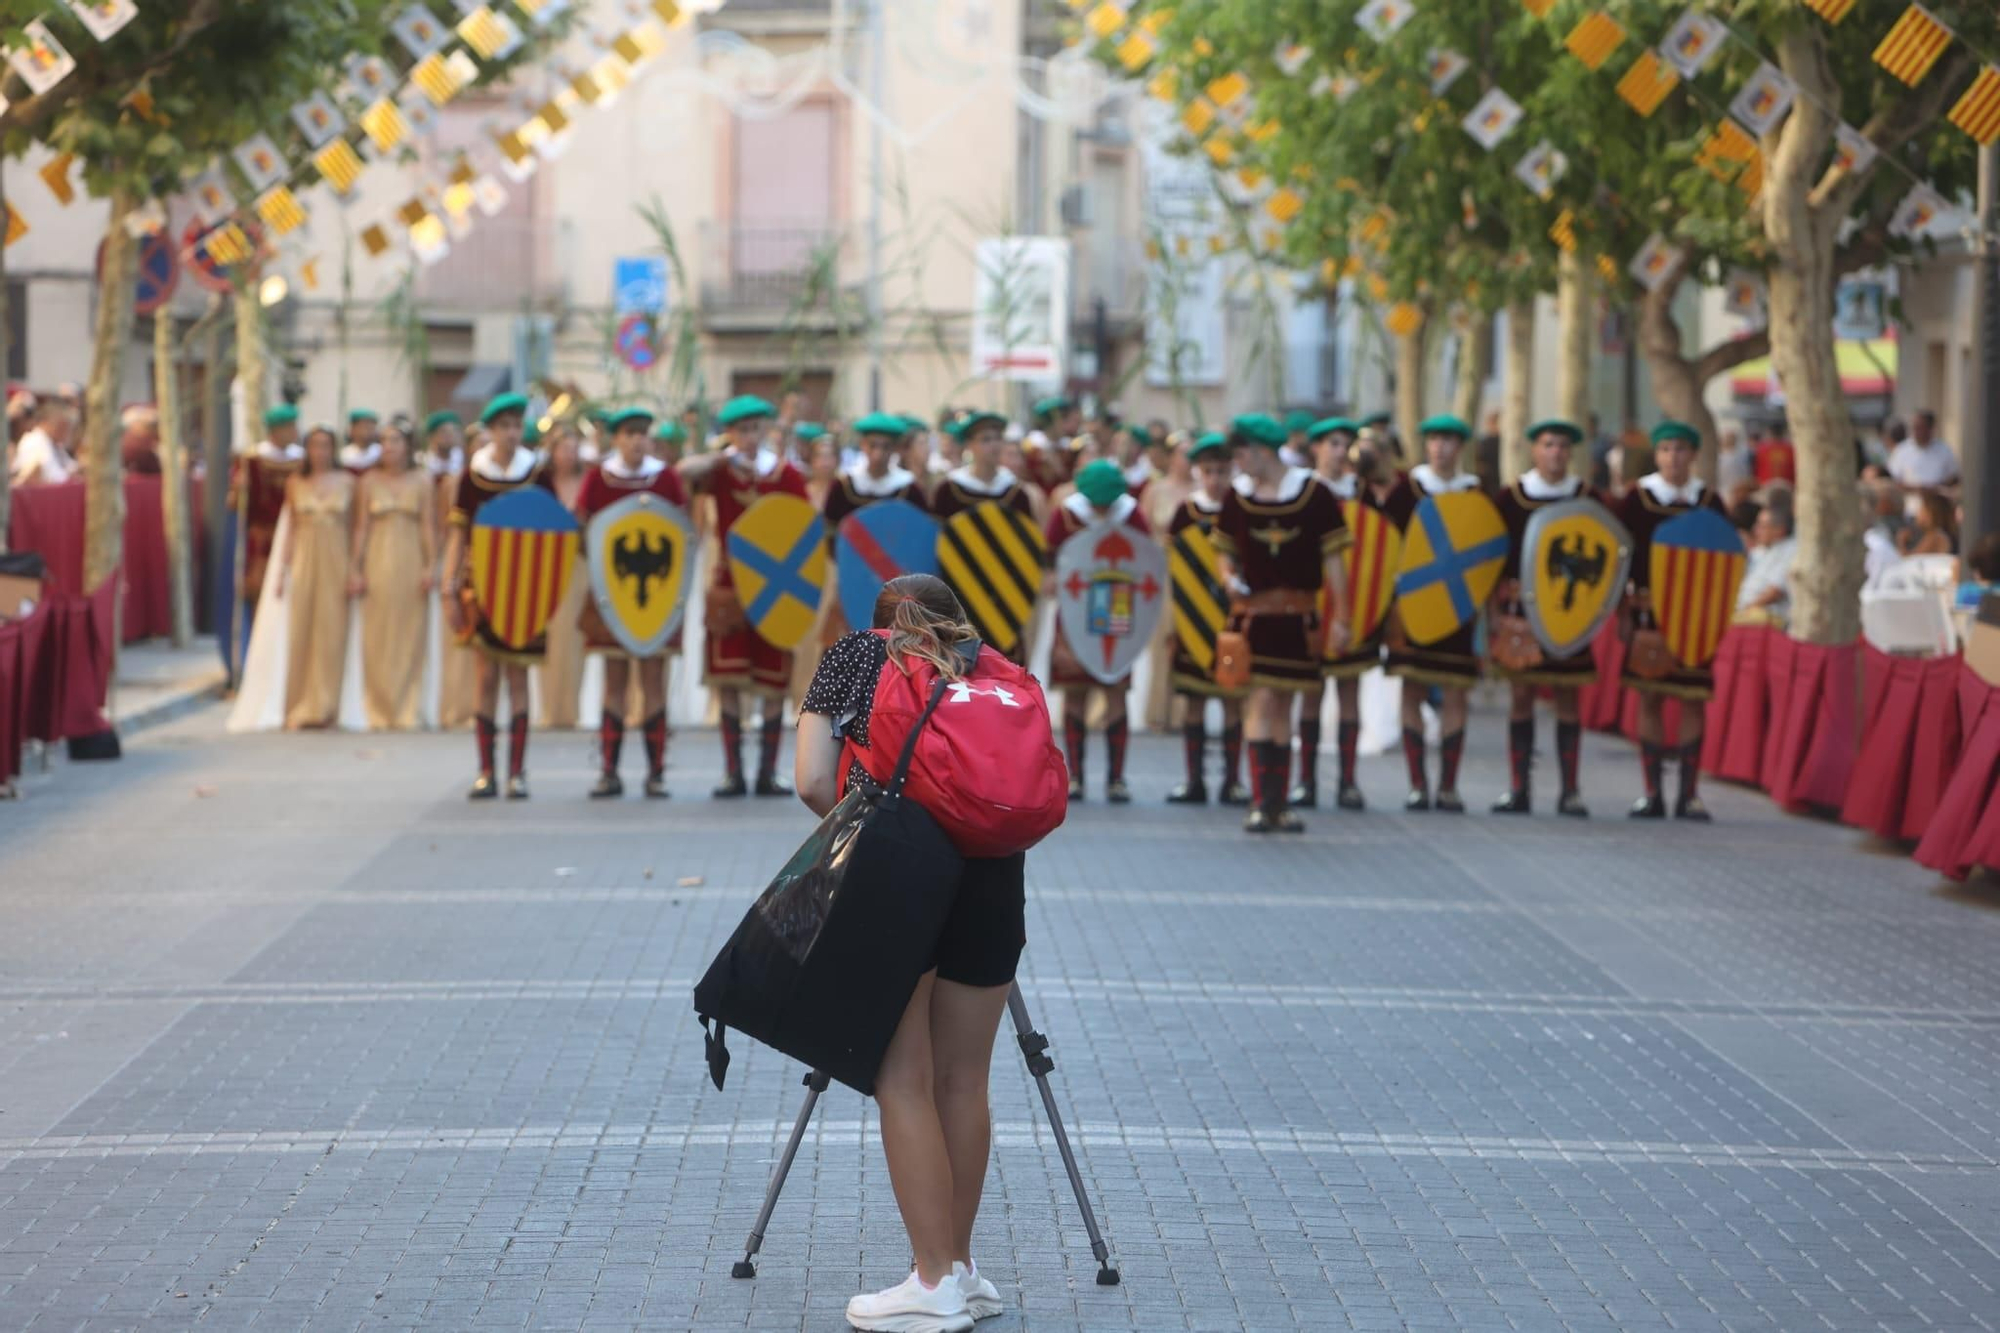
584,490 -> 694,656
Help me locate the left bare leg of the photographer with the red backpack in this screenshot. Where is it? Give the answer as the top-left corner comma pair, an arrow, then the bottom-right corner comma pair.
876,971 -> 960,1285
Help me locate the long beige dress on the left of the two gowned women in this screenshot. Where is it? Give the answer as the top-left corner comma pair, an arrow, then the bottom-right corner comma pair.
284,472 -> 354,729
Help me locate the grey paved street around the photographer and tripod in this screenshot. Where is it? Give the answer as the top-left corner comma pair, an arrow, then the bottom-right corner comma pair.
0,709 -> 2000,1333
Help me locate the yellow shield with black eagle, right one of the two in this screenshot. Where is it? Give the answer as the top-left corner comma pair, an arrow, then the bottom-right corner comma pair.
1520,498 -> 1632,658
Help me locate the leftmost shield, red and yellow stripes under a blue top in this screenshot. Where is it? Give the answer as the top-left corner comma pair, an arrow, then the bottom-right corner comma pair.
468,486 -> 582,650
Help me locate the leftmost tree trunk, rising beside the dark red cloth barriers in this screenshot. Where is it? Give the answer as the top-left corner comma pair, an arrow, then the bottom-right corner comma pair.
82,190 -> 138,592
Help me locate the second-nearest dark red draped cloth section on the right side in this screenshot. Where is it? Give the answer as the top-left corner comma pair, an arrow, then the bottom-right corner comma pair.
1840,644 -> 1964,841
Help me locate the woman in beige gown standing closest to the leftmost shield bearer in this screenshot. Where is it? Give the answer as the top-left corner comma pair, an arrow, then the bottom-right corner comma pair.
352,424 -> 438,731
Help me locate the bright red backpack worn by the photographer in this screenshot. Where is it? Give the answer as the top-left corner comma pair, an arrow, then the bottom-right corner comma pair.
840,630 -> 1070,857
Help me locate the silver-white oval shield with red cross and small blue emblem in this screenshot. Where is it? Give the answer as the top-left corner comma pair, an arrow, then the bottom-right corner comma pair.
1056,522 -> 1168,685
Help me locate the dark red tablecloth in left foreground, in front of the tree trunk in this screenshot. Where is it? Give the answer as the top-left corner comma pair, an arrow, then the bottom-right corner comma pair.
0,578 -> 116,783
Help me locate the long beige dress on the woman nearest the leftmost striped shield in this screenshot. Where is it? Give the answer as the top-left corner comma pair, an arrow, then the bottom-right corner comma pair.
362,470 -> 430,731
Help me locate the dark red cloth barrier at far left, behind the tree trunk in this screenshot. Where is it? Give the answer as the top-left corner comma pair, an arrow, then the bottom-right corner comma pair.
8,476 -> 202,642
